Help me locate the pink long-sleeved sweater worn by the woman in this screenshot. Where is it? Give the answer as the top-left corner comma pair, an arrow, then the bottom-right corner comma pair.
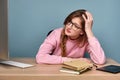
36,28 -> 105,64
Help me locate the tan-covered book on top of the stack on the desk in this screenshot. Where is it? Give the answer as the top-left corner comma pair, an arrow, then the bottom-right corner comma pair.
62,60 -> 93,71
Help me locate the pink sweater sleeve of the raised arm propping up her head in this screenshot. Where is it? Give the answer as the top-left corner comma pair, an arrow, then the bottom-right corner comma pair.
87,37 -> 106,64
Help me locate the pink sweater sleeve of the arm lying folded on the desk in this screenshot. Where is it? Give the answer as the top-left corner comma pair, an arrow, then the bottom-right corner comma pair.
36,31 -> 66,64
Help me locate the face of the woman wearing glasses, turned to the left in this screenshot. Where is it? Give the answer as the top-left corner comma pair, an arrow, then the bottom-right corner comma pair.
65,17 -> 83,39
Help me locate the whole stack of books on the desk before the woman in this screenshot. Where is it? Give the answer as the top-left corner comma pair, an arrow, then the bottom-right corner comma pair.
60,60 -> 93,74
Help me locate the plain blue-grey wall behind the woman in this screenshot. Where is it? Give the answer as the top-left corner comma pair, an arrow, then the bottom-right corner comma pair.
9,0 -> 120,62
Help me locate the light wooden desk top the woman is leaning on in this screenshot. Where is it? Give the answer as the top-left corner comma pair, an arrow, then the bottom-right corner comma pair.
0,58 -> 120,80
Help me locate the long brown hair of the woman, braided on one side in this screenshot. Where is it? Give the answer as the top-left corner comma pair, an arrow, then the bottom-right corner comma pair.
60,9 -> 87,57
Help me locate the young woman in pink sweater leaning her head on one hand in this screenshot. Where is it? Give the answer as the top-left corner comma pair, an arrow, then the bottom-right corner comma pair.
36,9 -> 105,64
